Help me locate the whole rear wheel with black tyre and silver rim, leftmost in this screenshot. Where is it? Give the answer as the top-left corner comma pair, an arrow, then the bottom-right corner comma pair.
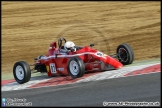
13,61 -> 31,84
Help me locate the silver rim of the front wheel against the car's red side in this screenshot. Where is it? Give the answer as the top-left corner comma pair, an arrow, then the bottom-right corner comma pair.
70,61 -> 79,75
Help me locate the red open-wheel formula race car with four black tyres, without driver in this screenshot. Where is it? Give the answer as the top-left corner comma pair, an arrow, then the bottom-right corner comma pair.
13,38 -> 134,84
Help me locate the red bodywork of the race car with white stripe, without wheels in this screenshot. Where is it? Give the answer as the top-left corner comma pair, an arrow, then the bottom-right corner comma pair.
36,42 -> 123,76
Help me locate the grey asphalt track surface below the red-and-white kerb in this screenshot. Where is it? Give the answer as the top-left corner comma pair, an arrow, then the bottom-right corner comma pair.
2,72 -> 161,107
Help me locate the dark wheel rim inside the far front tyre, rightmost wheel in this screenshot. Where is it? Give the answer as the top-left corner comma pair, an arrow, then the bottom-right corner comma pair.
118,48 -> 128,62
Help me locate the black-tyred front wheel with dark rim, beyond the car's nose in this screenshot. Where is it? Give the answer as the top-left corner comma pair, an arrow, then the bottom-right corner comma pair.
117,43 -> 134,65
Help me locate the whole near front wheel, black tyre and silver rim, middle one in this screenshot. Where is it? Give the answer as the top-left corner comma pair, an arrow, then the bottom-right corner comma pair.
67,57 -> 85,78
